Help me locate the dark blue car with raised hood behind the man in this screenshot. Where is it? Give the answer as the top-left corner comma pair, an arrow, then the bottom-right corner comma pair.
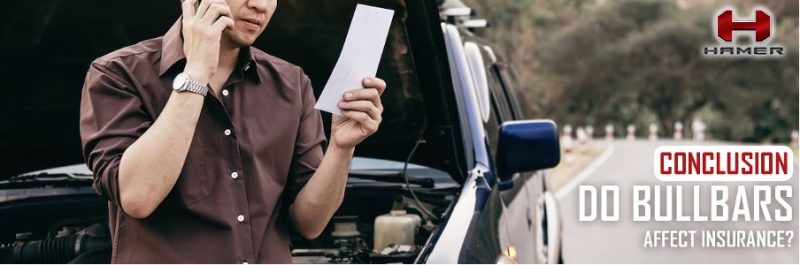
0,0 -> 561,263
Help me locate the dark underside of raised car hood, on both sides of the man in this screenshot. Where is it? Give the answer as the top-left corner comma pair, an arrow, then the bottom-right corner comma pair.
0,0 -> 426,177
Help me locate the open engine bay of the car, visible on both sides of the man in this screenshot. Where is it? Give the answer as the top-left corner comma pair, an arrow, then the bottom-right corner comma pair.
0,171 -> 458,264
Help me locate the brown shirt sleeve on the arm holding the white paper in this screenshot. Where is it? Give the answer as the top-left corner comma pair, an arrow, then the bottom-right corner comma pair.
284,71 -> 327,206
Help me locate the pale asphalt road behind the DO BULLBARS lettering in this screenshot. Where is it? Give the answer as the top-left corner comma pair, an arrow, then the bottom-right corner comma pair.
557,140 -> 800,264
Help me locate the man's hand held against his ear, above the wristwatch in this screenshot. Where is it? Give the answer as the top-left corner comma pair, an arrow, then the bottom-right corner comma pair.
181,0 -> 234,83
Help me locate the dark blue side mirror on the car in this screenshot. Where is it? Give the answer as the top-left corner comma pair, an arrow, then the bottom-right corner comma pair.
497,120 -> 561,181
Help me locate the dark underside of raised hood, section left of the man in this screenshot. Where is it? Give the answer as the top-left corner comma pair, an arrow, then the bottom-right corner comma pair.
0,0 -> 180,177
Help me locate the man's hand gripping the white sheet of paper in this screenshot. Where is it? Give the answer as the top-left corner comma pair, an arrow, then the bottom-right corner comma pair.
331,77 -> 386,149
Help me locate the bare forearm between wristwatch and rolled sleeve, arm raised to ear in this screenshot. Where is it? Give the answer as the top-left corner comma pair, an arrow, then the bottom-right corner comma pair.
119,89 -> 204,218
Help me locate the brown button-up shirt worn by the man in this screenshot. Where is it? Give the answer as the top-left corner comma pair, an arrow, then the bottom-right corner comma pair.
80,22 -> 326,263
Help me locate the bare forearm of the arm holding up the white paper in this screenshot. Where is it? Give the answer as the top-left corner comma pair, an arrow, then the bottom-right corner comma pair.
289,144 -> 354,239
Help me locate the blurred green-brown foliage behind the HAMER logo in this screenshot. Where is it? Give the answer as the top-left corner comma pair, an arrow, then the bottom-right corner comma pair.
465,0 -> 798,142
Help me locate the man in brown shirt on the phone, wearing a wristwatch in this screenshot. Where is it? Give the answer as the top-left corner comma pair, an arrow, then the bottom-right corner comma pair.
80,0 -> 386,263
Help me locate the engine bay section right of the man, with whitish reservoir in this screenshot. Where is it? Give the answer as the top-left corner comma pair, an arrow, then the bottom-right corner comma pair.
292,185 -> 454,264
